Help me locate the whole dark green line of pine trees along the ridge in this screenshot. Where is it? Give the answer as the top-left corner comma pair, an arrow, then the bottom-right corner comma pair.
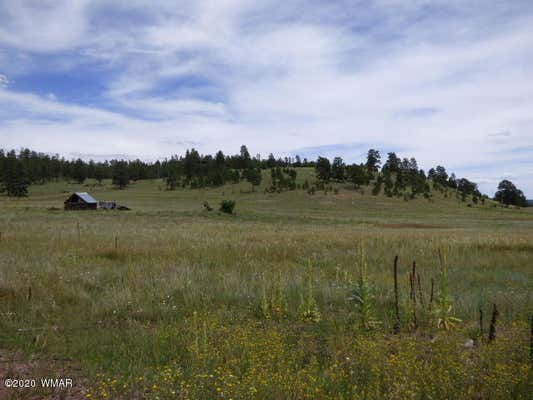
0,145 -> 527,206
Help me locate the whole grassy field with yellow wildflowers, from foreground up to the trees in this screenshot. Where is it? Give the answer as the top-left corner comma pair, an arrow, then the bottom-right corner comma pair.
0,171 -> 533,399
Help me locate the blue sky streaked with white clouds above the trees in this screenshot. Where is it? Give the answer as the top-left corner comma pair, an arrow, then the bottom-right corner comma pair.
0,0 -> 533,198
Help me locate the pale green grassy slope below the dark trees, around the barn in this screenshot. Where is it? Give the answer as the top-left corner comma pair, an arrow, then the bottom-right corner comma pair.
0,173 -> 533,231
